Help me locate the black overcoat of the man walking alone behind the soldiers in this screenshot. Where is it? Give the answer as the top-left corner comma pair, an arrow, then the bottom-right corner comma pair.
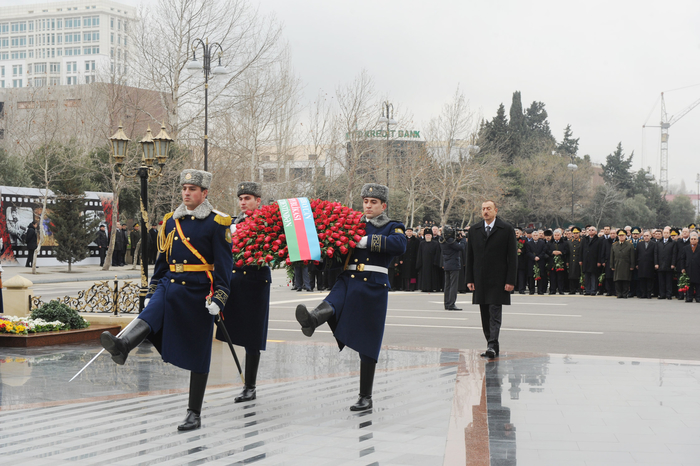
467,217 -> 518,304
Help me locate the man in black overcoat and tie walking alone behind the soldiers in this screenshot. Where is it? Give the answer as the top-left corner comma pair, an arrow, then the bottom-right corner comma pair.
467,200 -> 518,359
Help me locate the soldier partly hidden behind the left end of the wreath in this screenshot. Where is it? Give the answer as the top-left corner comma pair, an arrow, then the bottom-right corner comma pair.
216,181 -> 272,403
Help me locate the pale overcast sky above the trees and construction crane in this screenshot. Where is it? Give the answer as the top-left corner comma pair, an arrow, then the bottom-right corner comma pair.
9,0 -> 700,192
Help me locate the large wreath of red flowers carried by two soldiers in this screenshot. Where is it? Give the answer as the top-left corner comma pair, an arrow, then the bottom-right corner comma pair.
231,199 -> 365,269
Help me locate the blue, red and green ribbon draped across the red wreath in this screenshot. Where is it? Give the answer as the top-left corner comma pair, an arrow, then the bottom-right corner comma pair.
277,197 -> 321,262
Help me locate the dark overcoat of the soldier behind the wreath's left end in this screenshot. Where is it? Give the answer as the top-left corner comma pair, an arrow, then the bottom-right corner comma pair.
216,217 -> 272,351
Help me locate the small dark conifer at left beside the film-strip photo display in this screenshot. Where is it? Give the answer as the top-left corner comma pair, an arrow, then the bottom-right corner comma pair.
49,177 -> 99,272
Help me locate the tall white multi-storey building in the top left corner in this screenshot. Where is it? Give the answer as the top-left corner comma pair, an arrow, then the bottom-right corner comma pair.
0,0 -> 136,88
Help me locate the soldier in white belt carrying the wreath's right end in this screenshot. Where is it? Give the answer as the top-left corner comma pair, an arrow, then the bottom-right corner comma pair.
296,183 -> 406,411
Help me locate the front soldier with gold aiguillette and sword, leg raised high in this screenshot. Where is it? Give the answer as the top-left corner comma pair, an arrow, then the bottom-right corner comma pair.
100,170 -> 233,430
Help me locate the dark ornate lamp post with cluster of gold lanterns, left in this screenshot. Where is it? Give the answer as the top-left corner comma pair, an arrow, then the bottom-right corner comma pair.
109,125 -> 172,312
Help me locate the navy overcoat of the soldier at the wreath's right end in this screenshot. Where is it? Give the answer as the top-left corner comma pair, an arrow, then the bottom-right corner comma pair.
325,217 -> 406,360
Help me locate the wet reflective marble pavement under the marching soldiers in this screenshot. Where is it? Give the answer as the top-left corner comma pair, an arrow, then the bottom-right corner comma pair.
0,342 -> 700,466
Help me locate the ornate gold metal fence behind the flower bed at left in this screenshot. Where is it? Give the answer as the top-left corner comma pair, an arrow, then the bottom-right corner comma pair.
29,280 -> 140,315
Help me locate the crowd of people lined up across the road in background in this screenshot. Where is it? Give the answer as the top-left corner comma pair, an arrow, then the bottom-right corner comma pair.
293,224 -> 700,304
